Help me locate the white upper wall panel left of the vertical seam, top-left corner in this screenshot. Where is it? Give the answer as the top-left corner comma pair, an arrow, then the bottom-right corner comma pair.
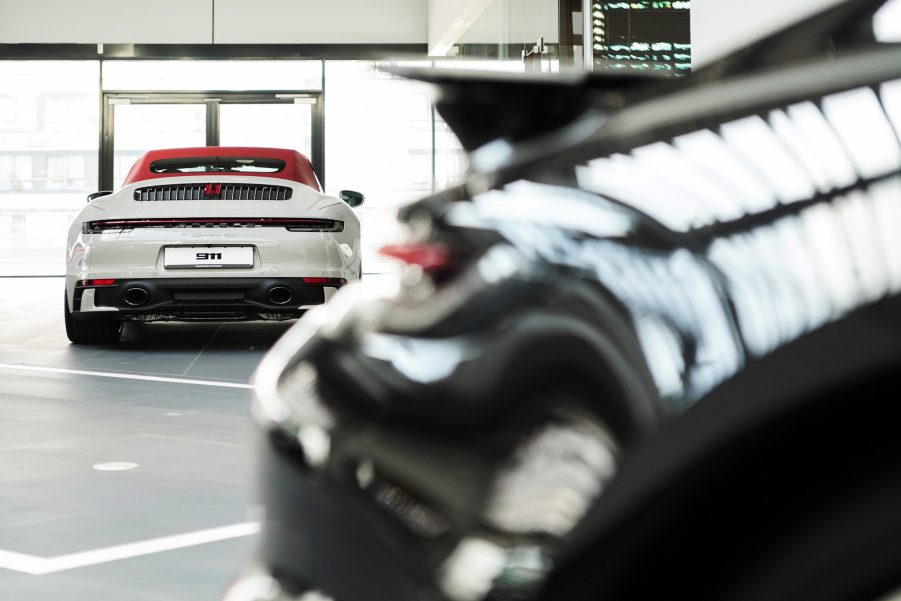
0,0 -> 213,44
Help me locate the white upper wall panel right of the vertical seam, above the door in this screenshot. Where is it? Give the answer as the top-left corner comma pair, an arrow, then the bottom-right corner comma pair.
214,0 -> 427,44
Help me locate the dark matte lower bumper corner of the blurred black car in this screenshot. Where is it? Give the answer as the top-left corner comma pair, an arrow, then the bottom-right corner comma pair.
239,433 -> 432,601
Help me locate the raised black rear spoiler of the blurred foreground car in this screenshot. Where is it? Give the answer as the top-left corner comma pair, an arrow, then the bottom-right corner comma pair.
386,68 -> 663,152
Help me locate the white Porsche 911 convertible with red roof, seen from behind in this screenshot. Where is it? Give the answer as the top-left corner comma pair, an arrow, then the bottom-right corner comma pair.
65,146 -> 363,344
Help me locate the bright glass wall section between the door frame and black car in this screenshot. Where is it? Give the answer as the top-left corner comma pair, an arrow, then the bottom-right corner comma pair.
325,61 -> 466,272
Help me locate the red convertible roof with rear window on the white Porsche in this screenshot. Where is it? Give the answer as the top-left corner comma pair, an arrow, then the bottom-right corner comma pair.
123,146 -> 322,192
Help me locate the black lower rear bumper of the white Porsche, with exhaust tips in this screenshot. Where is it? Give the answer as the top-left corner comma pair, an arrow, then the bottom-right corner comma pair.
72,277 -> 338,319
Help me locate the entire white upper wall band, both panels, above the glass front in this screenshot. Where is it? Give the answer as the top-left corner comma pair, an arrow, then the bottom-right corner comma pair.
0,0 -> 428,44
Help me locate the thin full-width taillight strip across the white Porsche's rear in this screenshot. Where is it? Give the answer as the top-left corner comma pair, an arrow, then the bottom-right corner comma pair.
81,217 -> 344,234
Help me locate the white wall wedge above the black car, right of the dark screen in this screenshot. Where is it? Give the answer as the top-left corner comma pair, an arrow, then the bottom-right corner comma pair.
691,0 -> 842,68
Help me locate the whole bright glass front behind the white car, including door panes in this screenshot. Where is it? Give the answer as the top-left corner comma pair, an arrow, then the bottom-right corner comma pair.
0,60 -> 466,276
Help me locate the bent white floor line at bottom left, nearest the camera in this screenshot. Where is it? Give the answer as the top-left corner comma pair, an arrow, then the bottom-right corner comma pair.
0,522 -> 260,576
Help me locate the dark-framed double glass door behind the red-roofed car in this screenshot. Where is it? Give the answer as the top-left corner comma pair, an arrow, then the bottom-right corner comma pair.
100,92 -> 325,190
